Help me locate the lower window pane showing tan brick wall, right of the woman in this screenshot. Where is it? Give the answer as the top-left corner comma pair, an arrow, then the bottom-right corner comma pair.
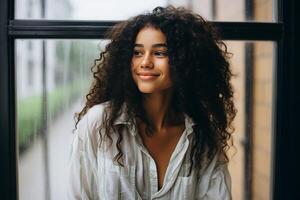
227,41 -> 276,199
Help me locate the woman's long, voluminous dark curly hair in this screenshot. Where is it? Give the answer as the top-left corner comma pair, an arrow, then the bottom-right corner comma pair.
76,6 -> 236,173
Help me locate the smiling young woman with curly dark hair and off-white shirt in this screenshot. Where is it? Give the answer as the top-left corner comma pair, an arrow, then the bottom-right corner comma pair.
69,7 -> 236,200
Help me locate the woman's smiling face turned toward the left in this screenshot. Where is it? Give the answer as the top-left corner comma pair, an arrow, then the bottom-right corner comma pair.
131,27 -> 172,93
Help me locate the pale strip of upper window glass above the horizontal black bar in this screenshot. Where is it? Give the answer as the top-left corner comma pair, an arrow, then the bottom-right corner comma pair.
15,0 -> 274,21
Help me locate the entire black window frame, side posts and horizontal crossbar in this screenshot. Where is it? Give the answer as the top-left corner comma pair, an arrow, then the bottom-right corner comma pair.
0,0 -> 300,199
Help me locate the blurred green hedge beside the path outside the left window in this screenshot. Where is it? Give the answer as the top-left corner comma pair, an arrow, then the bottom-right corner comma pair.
17,81 -> 87,150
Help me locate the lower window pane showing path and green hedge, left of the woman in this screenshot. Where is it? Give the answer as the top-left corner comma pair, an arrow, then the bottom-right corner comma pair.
16,40 -> 105,200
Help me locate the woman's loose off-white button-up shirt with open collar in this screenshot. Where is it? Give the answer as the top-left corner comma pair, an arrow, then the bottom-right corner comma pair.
68,103 -> 231,200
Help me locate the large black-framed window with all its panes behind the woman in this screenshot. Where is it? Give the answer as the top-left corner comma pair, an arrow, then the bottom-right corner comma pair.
0,0 -> 299,200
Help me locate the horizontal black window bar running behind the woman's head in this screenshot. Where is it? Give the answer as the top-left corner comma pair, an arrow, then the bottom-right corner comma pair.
9,20 -> 283,40
